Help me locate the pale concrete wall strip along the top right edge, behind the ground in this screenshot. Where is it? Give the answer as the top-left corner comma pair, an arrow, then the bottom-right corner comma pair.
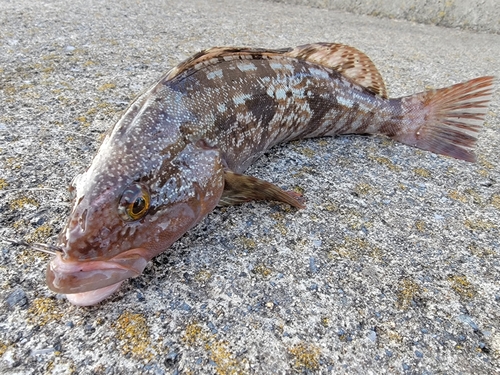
268,0 -> 500,34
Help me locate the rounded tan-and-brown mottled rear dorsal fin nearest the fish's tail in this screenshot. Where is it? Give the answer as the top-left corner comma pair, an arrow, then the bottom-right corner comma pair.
285,43 -> 387,98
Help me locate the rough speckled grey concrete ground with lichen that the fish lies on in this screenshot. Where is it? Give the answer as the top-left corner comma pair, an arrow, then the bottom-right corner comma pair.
0,0 -> 500,374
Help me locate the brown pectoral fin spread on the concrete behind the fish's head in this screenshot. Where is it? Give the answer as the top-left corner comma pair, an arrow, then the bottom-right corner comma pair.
219,171 -> 304,208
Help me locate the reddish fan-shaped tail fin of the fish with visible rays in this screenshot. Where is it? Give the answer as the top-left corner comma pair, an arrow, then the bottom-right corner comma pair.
392,77 -> 495,162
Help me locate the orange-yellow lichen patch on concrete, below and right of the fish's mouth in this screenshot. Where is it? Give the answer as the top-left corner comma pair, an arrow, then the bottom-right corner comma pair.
113,311 -> 153,360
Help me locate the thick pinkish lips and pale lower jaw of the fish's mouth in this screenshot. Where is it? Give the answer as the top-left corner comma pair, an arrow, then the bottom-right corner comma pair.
47,248 -> 151,306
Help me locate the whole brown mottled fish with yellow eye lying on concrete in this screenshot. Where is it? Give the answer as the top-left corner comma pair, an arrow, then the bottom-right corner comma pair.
44,43 -> 495,306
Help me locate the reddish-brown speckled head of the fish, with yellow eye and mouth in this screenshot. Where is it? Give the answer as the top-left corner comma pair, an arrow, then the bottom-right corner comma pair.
47,97 -> 224,306
